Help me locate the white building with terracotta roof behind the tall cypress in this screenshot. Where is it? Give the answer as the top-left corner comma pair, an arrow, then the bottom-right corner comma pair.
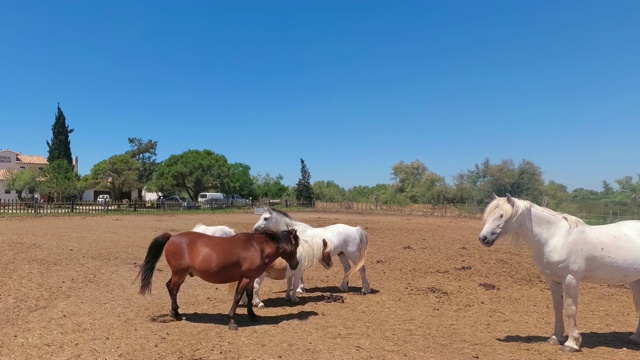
0,149 -> 78,201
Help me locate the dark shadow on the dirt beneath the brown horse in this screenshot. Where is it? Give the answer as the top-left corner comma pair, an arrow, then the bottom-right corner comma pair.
151,311 -> 318,327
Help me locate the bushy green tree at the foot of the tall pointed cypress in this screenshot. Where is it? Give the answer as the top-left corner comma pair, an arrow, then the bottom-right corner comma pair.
40,159 -> 79,201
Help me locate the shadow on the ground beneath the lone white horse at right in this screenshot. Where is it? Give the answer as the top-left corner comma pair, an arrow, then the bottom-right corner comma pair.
496,331 -> 640,350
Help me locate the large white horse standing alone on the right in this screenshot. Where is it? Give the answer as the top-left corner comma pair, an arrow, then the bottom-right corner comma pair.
479,194 -> 640,351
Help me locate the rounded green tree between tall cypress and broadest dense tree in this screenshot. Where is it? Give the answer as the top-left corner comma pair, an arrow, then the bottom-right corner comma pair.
89,154 -> 140,200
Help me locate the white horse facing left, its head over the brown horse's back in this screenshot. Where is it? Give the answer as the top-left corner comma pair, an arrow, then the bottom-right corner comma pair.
253,207 -> 371,294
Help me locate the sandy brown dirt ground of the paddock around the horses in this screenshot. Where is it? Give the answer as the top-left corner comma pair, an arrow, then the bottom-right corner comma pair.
0,212 -> 640,360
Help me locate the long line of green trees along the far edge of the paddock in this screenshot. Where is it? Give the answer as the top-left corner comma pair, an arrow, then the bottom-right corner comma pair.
9,105 -> 640,217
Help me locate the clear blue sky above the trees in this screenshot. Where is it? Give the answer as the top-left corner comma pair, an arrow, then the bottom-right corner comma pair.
0,0 -> 640,190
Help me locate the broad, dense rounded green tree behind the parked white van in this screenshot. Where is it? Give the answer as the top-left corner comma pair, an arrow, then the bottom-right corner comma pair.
151,150 -> 231,201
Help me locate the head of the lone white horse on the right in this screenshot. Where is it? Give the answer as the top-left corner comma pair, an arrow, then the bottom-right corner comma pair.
478,194 -> 517,247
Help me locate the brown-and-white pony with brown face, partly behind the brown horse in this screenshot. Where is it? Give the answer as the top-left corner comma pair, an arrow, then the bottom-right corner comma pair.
250,238 -> 333,309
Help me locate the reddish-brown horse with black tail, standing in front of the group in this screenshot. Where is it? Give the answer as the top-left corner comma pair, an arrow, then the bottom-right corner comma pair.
138,229 -> 300,330
